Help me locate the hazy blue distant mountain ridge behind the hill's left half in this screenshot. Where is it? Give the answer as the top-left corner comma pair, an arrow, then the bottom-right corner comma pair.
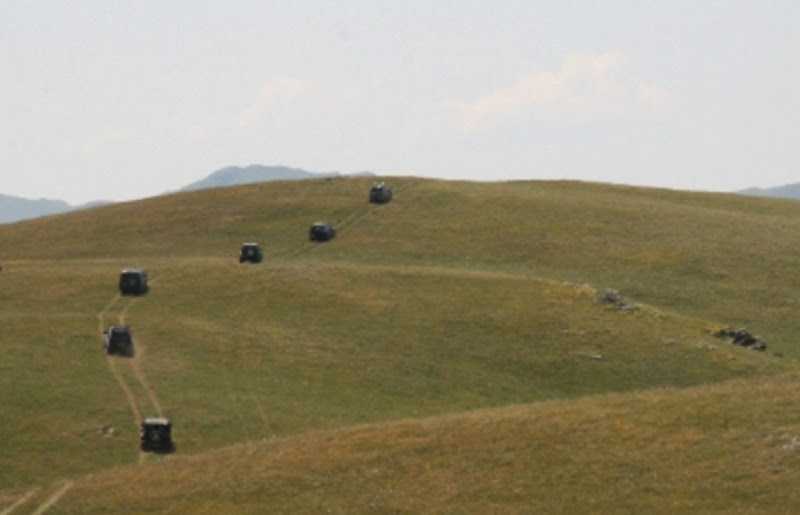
0,164 -> 374,224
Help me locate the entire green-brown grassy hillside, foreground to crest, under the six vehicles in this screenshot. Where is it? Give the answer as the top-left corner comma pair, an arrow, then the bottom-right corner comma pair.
0,178 -> 800,513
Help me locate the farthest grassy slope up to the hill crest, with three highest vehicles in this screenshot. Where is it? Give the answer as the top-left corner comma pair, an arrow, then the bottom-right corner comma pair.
6,179 -> 800,350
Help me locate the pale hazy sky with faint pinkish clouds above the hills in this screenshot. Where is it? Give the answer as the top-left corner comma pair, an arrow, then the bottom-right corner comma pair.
0,0 -> 800,204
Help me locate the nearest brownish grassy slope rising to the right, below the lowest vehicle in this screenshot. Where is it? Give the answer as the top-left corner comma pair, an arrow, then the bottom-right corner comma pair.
42,375 -> 800,513
